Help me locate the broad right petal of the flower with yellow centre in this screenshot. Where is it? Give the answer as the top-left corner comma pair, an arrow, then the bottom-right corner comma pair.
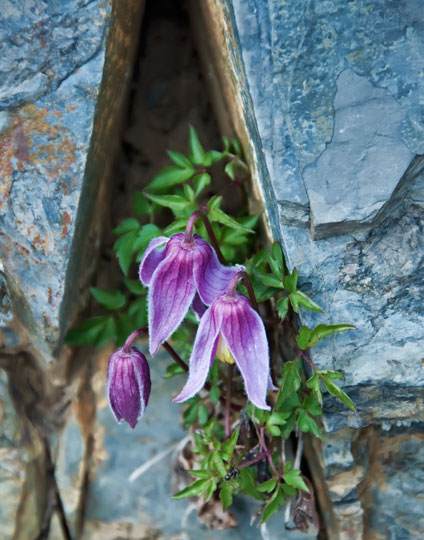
219,295 -> 270,410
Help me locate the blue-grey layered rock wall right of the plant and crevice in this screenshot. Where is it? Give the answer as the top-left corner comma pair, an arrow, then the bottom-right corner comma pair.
191,0 -> 424,539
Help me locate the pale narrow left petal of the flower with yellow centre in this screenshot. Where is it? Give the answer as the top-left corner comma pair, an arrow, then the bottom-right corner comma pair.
172,306 -> 222,403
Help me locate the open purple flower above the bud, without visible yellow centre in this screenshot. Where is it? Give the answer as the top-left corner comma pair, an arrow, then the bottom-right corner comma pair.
139,233 -> 240,356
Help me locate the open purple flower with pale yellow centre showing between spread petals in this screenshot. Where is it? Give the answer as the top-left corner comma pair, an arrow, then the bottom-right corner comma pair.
173,272 -> 273,410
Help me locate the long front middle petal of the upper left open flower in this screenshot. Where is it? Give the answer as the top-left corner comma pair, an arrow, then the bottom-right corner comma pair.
148,246 -> 196,356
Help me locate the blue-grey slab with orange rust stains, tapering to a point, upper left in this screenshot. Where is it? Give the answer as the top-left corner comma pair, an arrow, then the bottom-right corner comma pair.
0,0 -> 143,358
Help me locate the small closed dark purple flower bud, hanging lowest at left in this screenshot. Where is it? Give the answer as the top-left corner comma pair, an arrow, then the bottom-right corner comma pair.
106,330 -> 151,429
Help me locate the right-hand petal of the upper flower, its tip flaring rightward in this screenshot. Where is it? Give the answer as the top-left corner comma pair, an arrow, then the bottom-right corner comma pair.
194,242 -> 244,306
